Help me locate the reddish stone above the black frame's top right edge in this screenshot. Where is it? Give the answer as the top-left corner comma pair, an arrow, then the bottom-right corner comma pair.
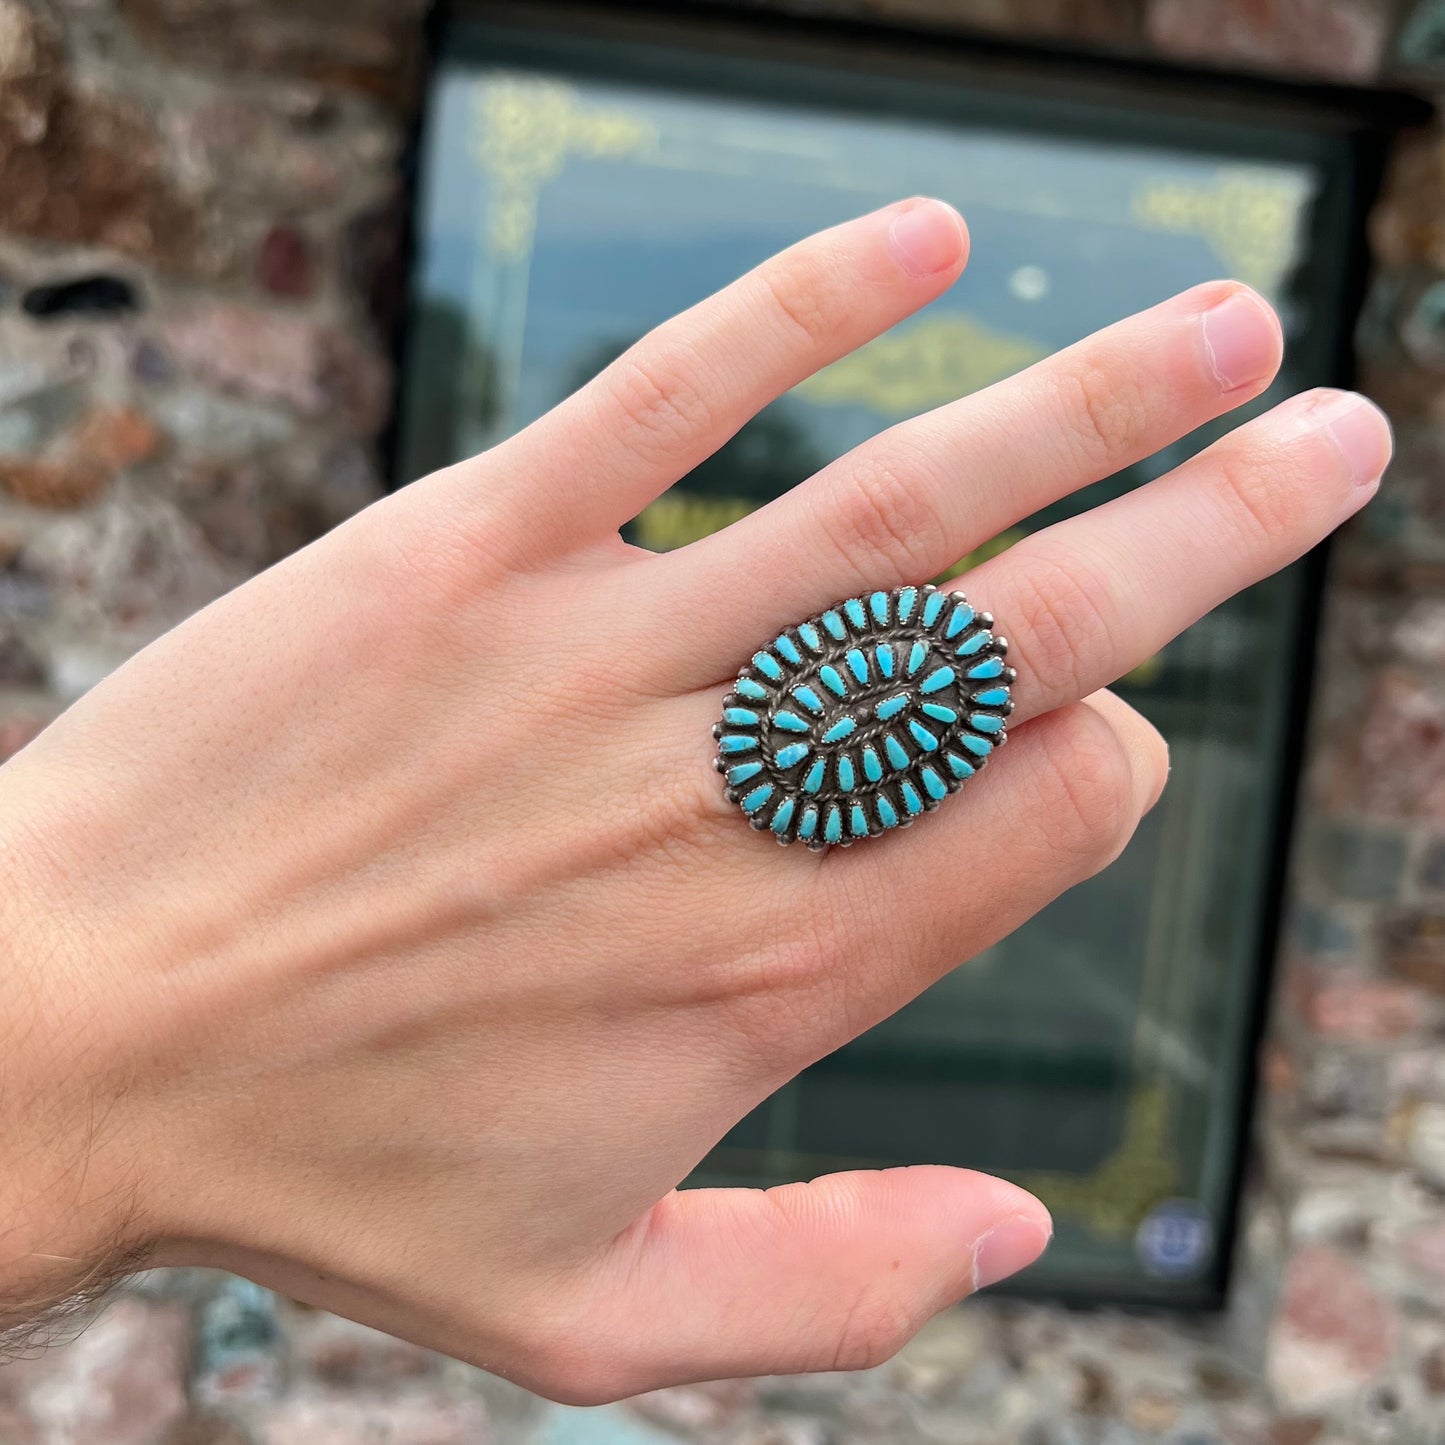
1146,0 -> 1390,81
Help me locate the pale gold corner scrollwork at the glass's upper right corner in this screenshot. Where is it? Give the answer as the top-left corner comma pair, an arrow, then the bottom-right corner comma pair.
1130,168 -> 1305,289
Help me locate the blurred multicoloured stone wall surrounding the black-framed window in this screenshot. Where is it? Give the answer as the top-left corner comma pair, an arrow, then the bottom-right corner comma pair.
0,0 -> 1445,1445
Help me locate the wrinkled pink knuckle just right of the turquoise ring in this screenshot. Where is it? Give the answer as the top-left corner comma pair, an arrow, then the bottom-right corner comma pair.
1009,549 -> 1114,708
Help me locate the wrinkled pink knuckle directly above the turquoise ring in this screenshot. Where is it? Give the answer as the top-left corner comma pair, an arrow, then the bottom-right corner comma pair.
824,452 -> 948,584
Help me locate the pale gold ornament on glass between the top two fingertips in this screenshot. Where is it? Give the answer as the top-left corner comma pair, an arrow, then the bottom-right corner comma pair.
796,312 -> 1052,416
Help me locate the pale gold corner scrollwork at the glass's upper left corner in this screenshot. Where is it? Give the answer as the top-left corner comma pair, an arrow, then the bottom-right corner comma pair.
471,75 -> 657,260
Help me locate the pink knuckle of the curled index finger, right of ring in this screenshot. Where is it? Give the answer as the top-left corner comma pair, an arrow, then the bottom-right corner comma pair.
1040,707 -> 1137,870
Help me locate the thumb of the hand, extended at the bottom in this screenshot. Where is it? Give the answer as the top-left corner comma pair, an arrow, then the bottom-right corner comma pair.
563,1165 -> 1052,1394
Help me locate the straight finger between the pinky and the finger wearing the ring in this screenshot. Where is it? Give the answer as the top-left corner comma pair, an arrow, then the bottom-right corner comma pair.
657,282 -> 1282,686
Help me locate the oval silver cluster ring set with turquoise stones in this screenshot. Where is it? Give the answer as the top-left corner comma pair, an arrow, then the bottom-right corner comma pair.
712,585 -> 1016,848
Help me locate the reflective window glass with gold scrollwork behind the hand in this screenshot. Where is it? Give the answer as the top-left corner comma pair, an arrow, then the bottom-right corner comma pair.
402,19 -> 1327,1298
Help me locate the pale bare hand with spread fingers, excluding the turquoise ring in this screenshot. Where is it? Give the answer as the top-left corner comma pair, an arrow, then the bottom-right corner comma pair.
0,199 -> 1390,1403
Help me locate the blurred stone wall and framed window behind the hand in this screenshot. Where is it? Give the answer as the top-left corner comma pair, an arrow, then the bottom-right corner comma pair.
0,0 -> 1445,1445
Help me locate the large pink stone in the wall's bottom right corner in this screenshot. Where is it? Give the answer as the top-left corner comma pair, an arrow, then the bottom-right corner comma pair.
1266,1244 -> 1399,1413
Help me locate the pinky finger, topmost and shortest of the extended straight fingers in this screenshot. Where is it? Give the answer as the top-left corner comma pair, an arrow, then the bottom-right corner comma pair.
454,198 -> 968,553
